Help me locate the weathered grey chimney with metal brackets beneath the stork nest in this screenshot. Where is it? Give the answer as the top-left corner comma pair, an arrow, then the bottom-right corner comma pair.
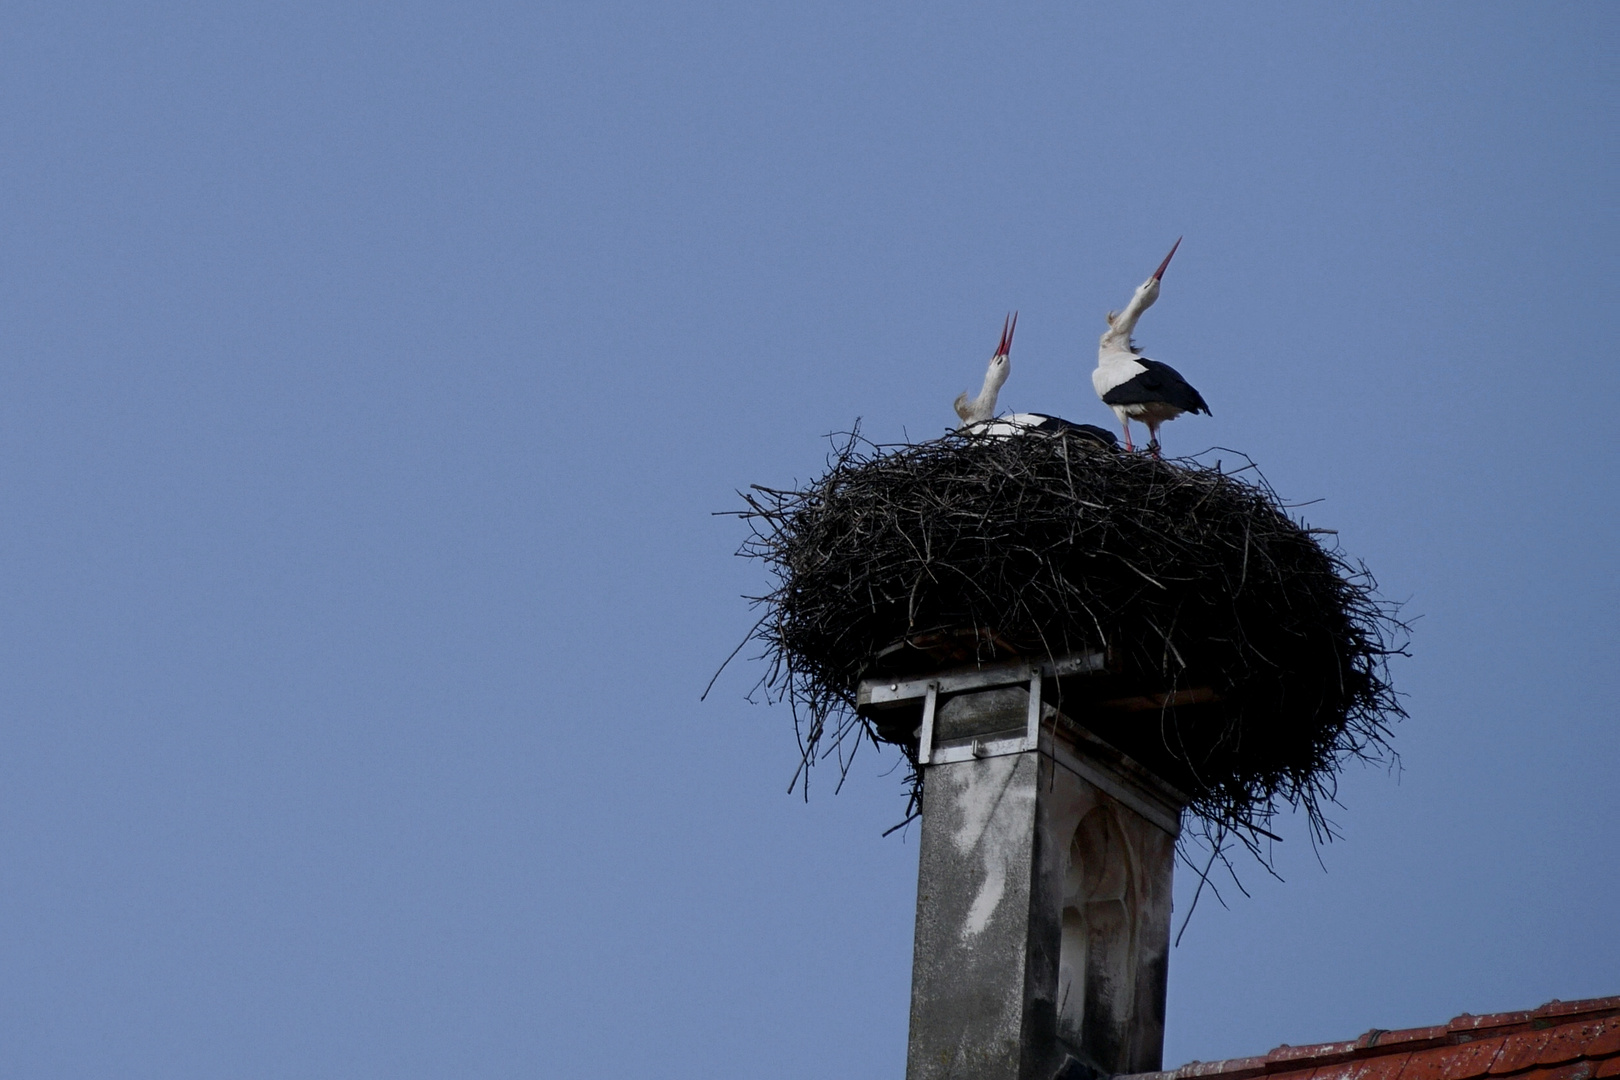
862,657 -> 1184,1080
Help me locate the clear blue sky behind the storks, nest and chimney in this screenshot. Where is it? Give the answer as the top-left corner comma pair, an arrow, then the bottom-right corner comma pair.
0,2 -> 1620,1080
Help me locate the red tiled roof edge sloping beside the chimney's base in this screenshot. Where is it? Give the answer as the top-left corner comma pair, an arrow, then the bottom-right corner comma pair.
1119,997 -> 1620,1080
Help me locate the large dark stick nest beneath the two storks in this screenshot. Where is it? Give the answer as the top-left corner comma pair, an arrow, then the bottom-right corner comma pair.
740,431 -> 1405,848
